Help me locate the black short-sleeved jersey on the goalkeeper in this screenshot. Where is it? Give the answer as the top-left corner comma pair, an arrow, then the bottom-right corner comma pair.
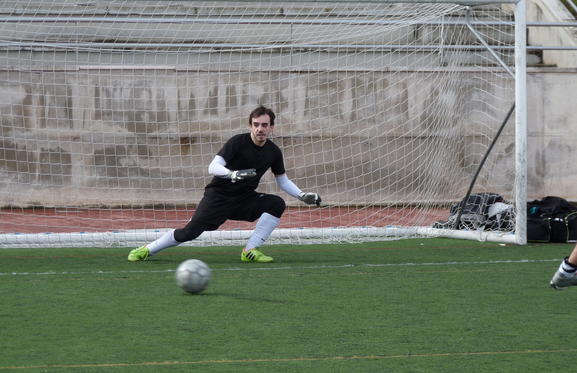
205,133 -> 285,195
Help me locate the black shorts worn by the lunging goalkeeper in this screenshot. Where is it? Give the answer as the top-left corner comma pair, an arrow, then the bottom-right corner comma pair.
189,191 -> 285,231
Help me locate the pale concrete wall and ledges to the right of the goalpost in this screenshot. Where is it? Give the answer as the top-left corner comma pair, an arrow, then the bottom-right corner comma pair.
527,0 -> 577,201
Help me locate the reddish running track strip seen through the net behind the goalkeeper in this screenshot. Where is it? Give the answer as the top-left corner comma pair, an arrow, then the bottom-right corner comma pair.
0,207 -> 449,233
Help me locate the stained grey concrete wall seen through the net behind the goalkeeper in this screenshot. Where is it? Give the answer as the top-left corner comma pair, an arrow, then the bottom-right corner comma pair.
0,69 -> 513,206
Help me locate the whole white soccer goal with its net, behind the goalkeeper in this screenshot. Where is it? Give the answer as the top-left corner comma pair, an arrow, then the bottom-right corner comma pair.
0,0 -> 526,247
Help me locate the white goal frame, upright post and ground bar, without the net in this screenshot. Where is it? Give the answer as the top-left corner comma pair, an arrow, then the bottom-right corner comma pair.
0,0 -> 527,247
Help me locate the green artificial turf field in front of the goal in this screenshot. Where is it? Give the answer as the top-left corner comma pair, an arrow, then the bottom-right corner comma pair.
0,239 -> 577,373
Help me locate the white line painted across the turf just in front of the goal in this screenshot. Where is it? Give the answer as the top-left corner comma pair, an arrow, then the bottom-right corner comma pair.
0,258 -> 561,276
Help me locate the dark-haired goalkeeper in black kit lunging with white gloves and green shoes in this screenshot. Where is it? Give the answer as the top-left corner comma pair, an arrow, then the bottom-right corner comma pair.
128,106 -> 321,263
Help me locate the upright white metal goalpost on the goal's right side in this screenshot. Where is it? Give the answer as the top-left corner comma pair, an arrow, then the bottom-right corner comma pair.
515,0 -> 527,245
